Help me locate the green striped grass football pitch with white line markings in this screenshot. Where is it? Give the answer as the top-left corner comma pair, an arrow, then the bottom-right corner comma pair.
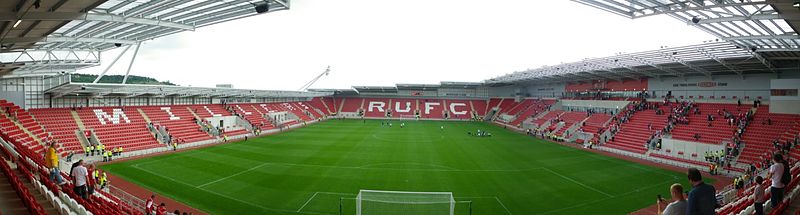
103,120 -> 708,215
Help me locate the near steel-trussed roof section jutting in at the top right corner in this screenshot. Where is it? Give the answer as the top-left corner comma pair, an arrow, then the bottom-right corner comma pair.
573,0 -> 800,49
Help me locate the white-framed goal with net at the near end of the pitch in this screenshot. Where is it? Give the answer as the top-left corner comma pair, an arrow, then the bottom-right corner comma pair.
356,190 -> 456,215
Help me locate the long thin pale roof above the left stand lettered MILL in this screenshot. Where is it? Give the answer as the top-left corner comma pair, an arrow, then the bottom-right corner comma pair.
45,80 -> 333,98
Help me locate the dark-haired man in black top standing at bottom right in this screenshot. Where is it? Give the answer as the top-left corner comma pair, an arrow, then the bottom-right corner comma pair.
686,168 -> 717,215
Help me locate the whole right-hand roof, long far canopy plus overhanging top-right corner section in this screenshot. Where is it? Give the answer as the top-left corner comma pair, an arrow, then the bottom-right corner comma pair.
484,0 -> 800,85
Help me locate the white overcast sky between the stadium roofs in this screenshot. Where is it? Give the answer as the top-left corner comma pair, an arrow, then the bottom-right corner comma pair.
79,0 -> 715,90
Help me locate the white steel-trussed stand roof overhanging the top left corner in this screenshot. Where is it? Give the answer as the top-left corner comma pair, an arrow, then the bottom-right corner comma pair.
0,0 -> 289,76
